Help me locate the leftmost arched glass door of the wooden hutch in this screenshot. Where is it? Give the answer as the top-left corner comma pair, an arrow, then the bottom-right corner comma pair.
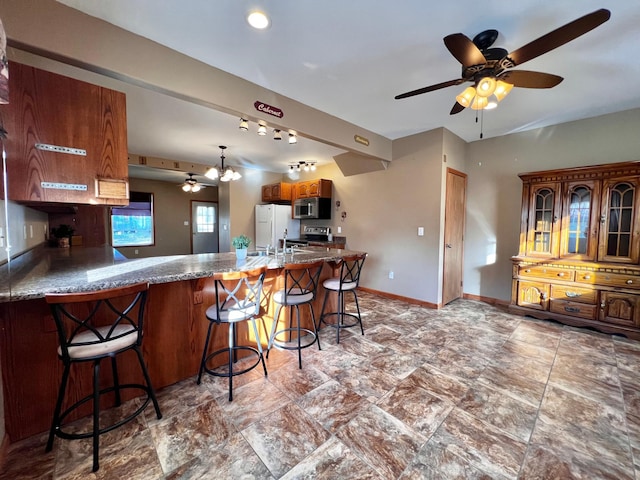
526,183 -> 560,257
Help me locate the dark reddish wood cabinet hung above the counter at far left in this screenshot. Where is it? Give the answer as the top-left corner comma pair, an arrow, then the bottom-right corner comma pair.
0,62 -> 129,205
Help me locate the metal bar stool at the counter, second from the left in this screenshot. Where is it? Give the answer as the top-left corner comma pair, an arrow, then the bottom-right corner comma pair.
197,266 -> 267,402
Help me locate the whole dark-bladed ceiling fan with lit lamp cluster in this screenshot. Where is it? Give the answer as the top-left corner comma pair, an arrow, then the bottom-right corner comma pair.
395,8 -> 611,115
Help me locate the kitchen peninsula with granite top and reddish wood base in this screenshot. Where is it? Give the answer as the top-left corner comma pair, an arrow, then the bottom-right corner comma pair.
0,247 -> 359,441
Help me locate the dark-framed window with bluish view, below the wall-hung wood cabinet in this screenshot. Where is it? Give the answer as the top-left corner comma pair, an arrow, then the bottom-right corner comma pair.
111,192 -> 154,247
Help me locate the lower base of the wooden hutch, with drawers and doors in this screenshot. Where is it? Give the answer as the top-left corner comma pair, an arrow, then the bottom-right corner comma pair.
509,259 -> 640,340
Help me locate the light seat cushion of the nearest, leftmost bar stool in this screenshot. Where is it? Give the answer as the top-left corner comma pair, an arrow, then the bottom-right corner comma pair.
58,324 -> 138,359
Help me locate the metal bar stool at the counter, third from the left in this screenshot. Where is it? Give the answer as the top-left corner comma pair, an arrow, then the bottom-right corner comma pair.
267,260 -> 324,368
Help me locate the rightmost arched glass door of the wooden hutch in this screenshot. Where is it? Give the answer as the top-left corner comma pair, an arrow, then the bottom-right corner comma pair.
598,178 -> 640,263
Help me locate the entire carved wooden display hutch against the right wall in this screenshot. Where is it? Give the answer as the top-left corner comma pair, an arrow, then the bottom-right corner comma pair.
509,162 -> 640,340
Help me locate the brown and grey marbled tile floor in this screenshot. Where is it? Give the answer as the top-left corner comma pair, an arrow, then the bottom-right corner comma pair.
0,293 -> 640,480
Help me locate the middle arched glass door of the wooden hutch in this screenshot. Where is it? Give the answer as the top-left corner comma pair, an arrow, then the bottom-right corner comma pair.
560,181 -> 600,260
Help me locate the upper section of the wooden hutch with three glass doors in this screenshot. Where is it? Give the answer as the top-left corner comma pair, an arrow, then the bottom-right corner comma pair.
519,163 -> 640,263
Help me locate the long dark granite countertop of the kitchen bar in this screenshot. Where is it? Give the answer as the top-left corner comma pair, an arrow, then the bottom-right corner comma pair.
0,246 -> 359,303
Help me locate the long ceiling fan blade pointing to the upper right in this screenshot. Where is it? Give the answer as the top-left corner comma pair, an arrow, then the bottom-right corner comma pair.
507,8 -> 611,66
